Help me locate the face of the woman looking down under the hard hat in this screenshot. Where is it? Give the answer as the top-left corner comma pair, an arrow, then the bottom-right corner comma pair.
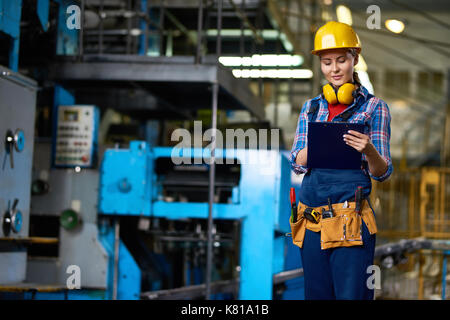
320,49 -> 358,88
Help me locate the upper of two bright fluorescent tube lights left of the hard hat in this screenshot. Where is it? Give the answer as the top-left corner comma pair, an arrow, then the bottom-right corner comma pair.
219,54 -> 303,67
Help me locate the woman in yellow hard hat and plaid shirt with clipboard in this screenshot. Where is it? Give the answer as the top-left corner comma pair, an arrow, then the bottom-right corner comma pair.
289,21 -> 393,300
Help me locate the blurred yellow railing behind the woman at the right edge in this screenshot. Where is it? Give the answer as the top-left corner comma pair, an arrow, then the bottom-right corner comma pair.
371,167 -> 450,239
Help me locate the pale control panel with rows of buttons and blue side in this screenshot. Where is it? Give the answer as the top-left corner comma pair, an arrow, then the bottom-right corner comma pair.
52,105 -> 100,168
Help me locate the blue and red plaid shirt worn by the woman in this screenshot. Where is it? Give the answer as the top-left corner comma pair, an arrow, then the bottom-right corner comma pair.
289,86 -> 393,181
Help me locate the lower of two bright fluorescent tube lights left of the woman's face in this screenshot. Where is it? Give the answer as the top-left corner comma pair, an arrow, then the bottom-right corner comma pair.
232,69 -> 313,79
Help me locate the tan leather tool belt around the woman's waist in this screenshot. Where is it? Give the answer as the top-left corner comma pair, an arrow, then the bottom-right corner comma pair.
289,199 -> 377,250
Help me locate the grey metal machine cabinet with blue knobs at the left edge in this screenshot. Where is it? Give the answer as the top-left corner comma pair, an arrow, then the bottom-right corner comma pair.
0,66 -> 37,285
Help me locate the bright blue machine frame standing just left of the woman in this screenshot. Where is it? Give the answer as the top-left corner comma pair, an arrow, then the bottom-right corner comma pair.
99,141 -> 291,299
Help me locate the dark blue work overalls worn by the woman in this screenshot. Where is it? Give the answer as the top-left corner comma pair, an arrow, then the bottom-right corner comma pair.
299,97 -> 375,300
